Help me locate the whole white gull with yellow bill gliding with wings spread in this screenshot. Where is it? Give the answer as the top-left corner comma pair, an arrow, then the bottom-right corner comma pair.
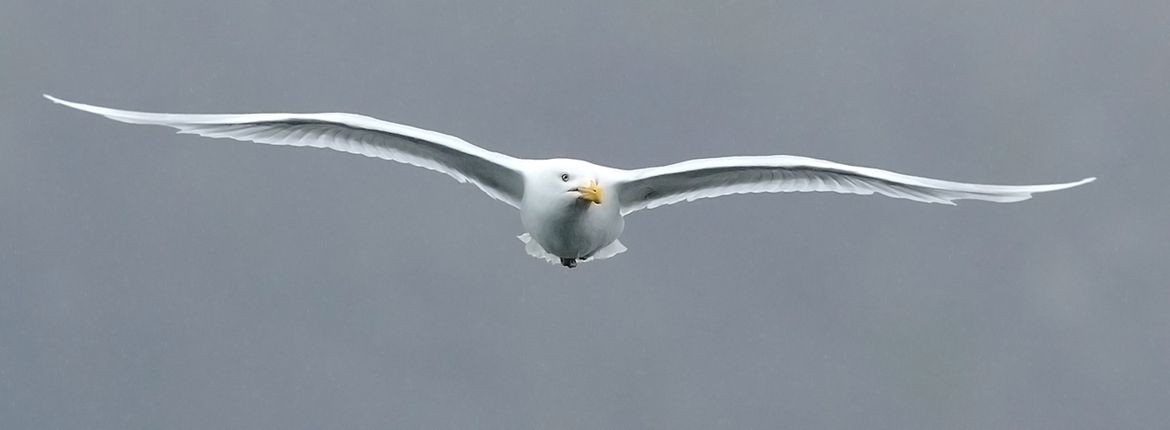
44,95 -> 1096,268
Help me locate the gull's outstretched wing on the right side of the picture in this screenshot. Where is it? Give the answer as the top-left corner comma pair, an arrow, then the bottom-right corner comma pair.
618,155 -> 1096,215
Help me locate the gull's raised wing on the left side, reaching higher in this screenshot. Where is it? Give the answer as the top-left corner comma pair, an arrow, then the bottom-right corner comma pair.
44,95 -> 524,207
